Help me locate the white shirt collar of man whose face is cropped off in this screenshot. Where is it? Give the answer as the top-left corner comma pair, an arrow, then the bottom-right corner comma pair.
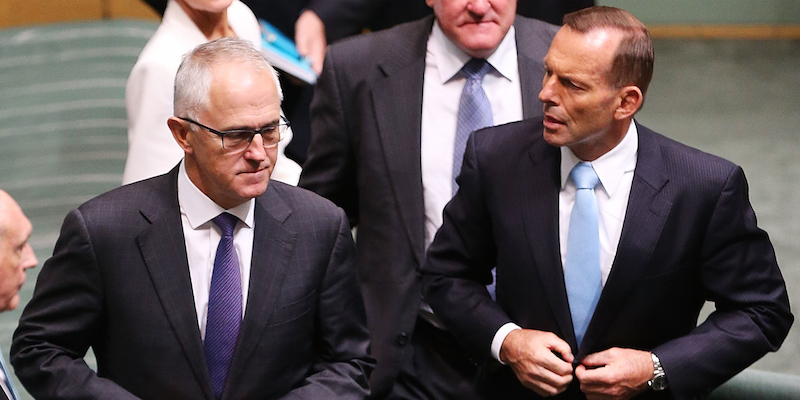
428,22 -> 519,84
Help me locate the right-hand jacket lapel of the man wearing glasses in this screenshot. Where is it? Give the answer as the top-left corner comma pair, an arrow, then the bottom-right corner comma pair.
223,184 -> 297,398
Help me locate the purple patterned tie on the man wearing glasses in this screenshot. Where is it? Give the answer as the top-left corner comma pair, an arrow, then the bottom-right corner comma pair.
204,213 -> 242,399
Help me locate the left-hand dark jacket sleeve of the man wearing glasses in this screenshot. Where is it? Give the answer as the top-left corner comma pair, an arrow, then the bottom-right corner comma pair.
11,210 -> 136,400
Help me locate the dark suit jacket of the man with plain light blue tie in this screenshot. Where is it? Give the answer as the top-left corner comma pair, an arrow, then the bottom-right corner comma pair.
423,118 -> 793,399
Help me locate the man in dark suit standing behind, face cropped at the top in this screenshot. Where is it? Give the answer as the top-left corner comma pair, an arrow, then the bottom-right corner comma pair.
300,0 -> 557,400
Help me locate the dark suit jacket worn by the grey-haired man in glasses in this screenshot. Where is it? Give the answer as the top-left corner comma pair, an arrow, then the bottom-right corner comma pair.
11,168 -> 373,400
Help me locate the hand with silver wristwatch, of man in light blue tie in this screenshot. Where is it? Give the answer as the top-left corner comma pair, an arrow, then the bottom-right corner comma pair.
575,347 -> 653,400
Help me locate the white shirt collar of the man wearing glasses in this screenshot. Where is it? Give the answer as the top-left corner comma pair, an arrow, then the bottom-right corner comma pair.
178,161 -> 256,229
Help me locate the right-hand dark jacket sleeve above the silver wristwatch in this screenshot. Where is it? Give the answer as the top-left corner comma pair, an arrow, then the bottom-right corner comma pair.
652,167 -> 794,399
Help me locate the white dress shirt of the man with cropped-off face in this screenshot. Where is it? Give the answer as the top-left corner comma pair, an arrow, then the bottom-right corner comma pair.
421,22 -> 522,249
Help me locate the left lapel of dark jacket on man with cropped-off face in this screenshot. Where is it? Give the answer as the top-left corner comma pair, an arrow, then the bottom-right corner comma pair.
372,17 -> 433,264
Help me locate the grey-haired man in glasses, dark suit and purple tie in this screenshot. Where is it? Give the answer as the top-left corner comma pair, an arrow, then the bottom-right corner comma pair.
12,37 -> 373,400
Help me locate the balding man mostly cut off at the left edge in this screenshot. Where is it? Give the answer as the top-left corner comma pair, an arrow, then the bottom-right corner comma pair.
0,190 -> 39,400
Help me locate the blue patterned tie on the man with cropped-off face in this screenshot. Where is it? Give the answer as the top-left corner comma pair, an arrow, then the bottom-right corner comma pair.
453,58 -> 492,194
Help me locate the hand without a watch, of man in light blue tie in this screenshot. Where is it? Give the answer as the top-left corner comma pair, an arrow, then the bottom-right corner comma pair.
500,329 -> 574,397
